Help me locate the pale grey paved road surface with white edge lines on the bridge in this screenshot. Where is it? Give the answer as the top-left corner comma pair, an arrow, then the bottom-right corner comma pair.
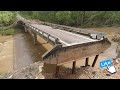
31,24 -> 98,46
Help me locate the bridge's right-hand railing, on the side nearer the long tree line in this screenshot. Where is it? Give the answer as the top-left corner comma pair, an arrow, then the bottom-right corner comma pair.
41,21 -> 106,40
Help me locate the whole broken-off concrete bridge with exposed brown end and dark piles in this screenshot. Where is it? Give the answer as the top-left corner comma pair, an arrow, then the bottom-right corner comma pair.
18,14 -> 111,75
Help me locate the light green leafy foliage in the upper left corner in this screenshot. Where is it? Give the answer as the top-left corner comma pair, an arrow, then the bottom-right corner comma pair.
0,11 -> 16,27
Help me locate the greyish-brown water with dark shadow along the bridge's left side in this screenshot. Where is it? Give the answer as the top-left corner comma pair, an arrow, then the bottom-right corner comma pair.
14,33 -> 52,69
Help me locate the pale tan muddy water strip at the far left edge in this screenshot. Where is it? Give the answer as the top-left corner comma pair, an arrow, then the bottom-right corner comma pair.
0,36 -> 13,75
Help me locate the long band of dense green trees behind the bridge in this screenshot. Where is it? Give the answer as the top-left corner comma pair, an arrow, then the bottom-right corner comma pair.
20,11 -> 120,27
